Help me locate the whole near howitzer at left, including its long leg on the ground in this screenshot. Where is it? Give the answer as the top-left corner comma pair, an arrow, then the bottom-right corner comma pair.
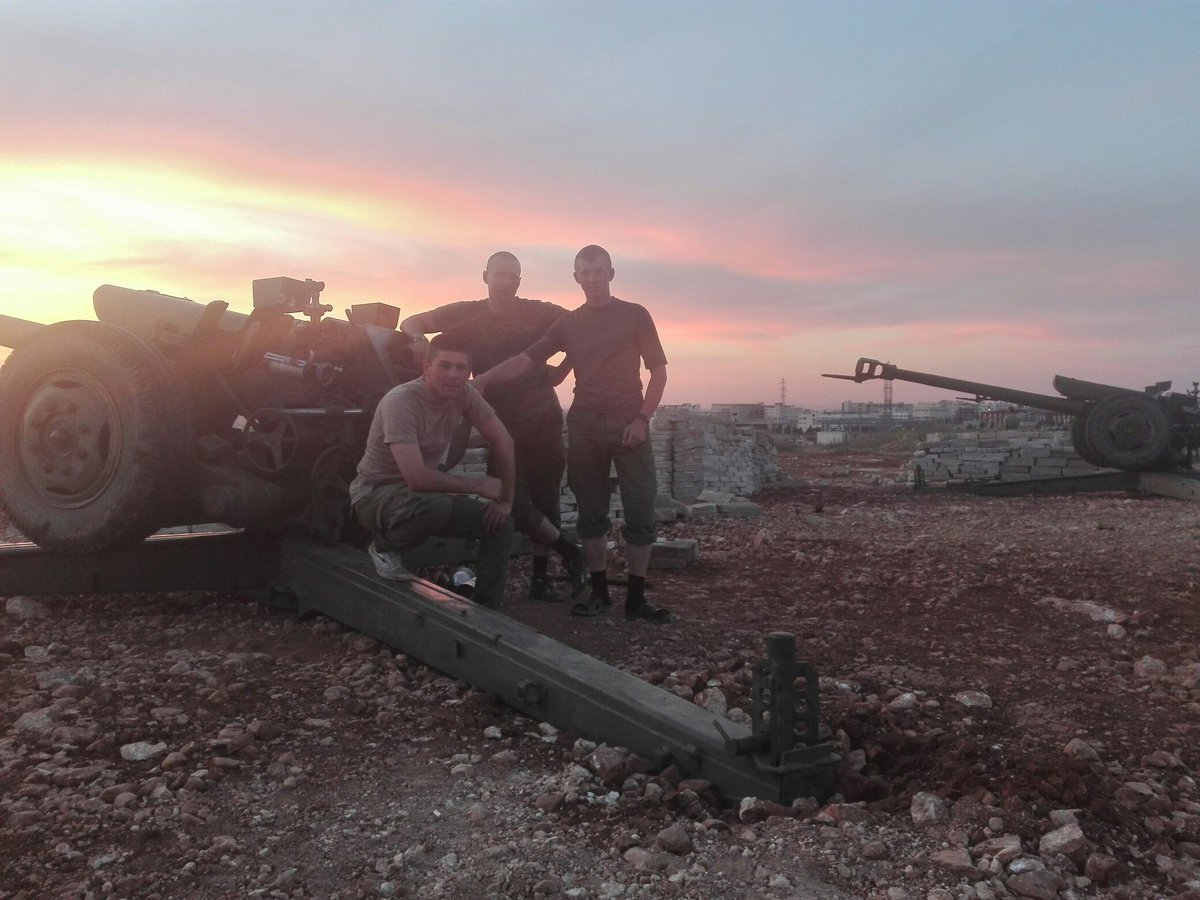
0,278 -> 840,803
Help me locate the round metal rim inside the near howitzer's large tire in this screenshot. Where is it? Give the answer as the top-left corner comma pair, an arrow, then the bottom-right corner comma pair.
20,371 -> 120,509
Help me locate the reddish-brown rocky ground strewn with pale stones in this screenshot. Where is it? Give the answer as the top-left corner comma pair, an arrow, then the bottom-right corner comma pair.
0,451 -> 1200,900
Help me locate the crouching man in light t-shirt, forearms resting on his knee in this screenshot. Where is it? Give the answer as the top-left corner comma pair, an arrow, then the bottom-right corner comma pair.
350,335 -> 516,610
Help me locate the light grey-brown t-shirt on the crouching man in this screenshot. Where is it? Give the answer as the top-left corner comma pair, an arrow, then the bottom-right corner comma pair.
350,378 -> 496,503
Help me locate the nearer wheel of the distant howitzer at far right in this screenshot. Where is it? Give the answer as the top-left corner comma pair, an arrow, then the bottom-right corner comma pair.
1084,394 -> 1171,472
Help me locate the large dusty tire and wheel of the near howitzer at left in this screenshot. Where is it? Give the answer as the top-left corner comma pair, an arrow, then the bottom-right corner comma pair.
0,322 -> 190,554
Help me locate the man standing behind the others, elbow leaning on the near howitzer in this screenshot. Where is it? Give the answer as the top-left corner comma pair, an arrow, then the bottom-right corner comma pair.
400,250 -> 587,602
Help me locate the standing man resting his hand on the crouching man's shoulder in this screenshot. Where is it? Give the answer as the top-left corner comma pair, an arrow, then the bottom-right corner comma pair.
475,244 -> 671,623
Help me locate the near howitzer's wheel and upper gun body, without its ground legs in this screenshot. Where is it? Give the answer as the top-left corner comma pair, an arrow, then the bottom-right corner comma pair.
0,277 -> 418,553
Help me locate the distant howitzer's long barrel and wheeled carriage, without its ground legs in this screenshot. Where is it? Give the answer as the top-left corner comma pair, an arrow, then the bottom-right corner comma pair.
824,356 -> 1200,472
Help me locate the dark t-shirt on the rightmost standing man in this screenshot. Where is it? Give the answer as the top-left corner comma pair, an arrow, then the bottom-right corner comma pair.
526,298 -> 667,415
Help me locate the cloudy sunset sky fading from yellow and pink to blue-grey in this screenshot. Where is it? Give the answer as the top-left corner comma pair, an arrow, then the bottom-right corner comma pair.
0,0 -> 1200,408
